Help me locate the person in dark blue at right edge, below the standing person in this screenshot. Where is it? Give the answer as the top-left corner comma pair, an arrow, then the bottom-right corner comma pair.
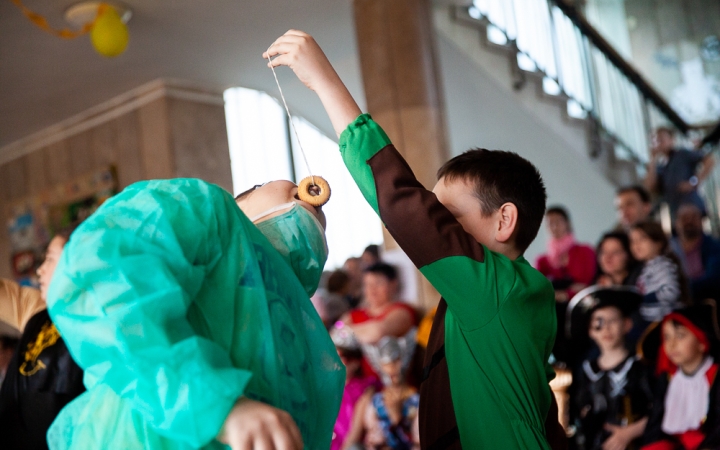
671,203 -> 720,300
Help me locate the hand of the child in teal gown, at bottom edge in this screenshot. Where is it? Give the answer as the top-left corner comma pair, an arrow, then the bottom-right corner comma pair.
218,398 -> 303,450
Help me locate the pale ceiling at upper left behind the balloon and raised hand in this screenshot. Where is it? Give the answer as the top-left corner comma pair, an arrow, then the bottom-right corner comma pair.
0,0 -> 363,149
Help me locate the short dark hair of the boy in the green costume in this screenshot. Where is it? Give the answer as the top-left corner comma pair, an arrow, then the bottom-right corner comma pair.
437,148 -> 547,252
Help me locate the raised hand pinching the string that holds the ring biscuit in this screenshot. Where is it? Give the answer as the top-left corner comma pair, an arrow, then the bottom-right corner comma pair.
263,30 -> 340,91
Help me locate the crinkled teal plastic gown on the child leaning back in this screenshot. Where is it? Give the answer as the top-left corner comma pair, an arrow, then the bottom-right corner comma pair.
48,179 -> 345,449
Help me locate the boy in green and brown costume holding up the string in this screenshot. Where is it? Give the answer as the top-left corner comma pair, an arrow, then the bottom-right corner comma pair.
264,30 -> 557,449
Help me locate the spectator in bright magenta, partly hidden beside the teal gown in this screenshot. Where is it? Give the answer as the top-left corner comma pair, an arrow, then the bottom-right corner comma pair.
330,322 -> 380,450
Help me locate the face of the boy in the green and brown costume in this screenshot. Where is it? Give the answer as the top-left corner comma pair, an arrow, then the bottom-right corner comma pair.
433,177 -> 502,253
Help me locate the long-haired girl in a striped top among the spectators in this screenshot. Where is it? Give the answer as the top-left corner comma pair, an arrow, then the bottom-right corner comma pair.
630,222 -> 689,325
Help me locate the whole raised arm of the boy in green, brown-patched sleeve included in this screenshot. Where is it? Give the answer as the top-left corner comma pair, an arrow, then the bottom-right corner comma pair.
265,30 -> 511,327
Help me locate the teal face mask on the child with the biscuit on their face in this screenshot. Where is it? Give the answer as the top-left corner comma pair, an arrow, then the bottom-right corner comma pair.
250,202 -> 328,296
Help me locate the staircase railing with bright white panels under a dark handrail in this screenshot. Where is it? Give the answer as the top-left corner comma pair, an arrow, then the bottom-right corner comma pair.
456,0 -> 689,168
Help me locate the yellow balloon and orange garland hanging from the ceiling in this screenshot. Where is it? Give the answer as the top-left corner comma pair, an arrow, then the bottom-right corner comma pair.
10,0 -> 129,58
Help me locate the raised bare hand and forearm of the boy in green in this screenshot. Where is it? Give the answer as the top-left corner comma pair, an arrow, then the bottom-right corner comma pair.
263,30 -> 362,136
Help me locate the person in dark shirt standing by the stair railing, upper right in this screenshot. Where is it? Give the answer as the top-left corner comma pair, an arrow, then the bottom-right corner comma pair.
645,127 -> 715,221
